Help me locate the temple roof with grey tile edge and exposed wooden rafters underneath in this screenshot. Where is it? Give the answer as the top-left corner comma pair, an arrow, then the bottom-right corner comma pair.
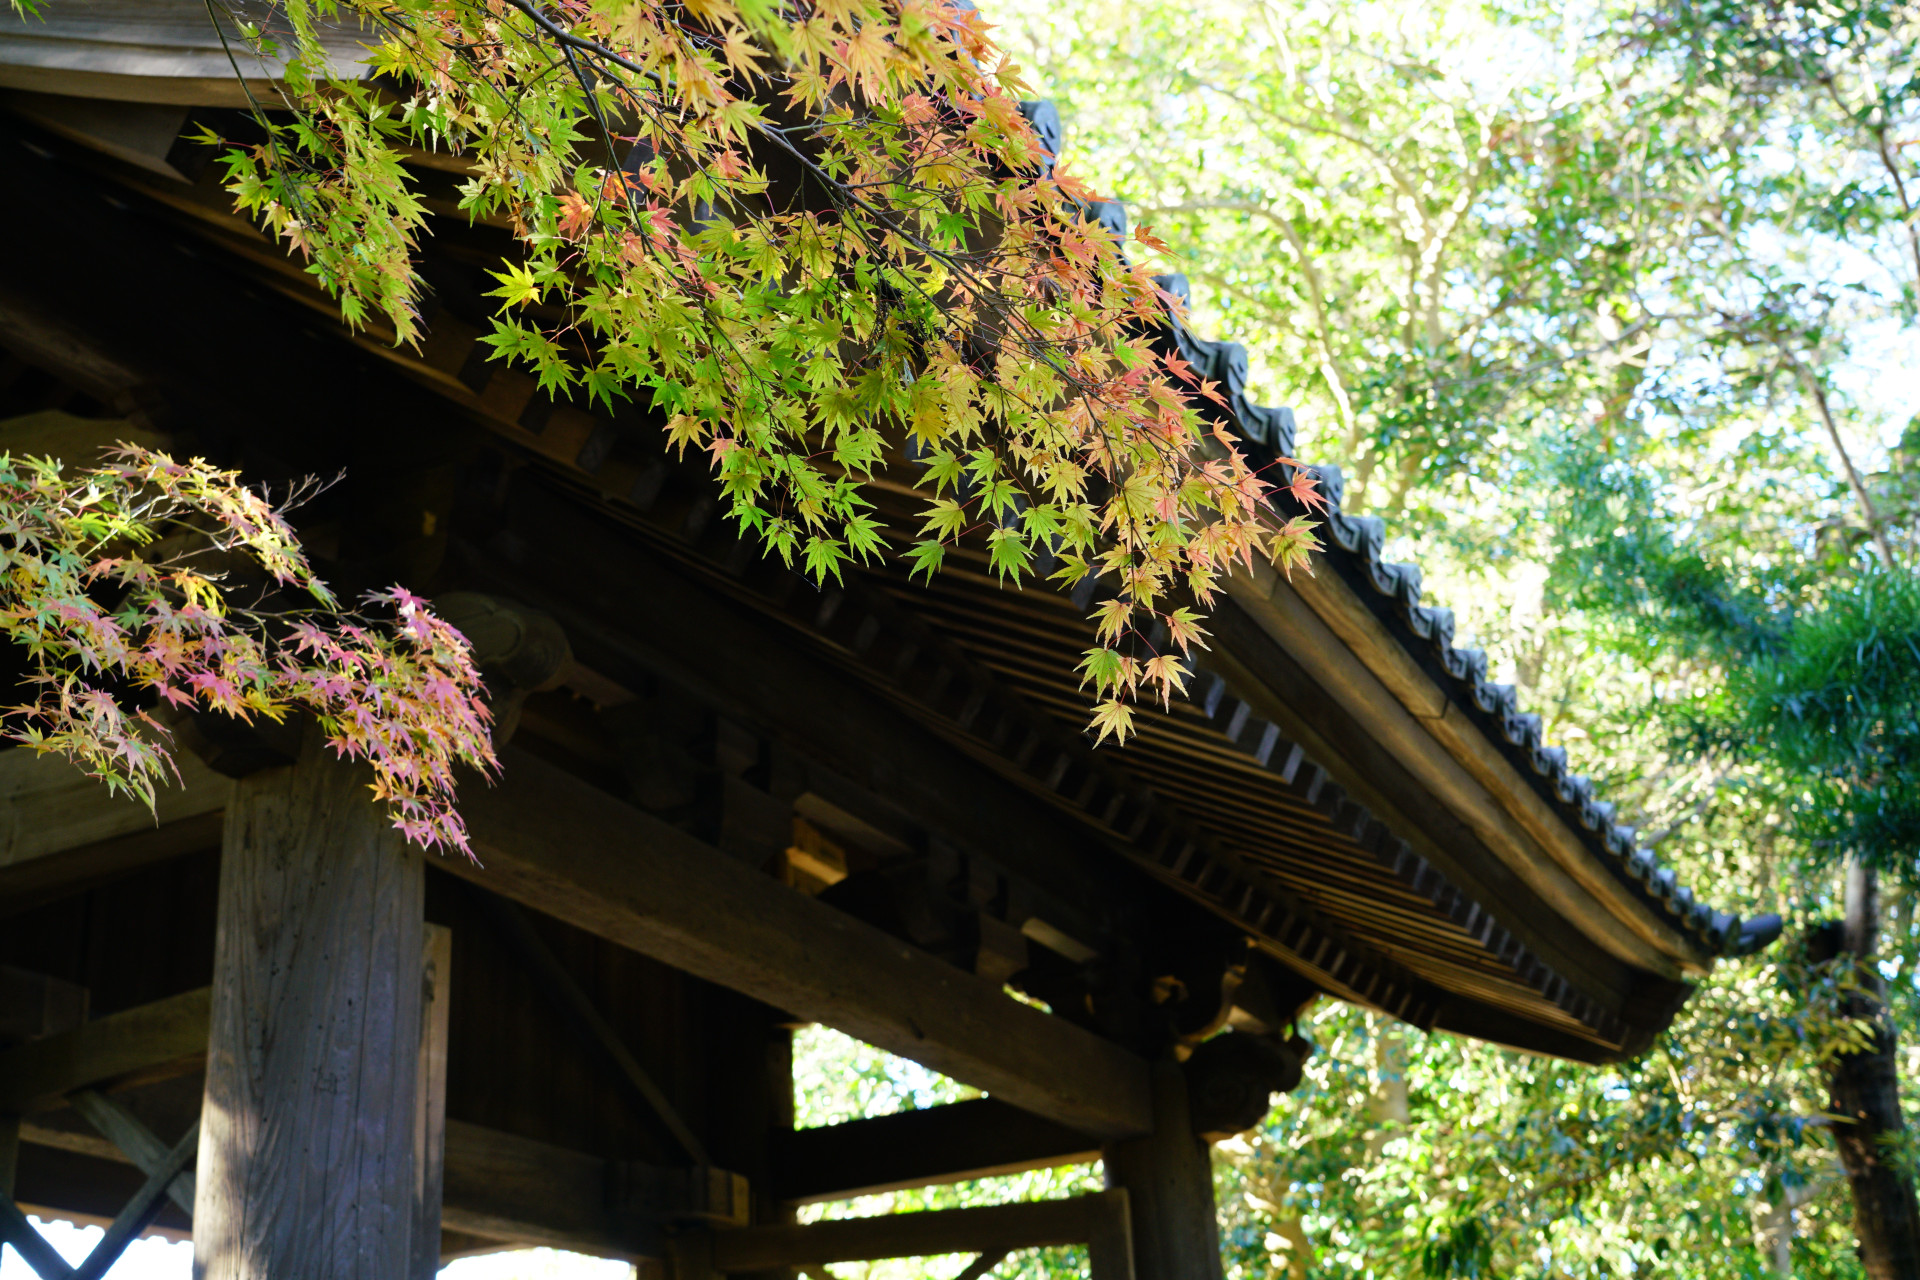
0,20 -> 1778,1059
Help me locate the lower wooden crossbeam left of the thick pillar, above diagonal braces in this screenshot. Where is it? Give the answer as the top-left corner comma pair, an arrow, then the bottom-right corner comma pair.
0,986 -> 211,1115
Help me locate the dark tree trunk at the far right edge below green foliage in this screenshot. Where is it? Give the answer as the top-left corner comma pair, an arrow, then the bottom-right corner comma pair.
1828,862 -> 1920,1280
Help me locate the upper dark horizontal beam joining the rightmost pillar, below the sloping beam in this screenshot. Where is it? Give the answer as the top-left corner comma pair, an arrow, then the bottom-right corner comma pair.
774,1098 -> 1100,1203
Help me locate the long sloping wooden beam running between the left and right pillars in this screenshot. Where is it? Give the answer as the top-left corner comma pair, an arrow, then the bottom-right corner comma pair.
444,748 -> 1152,1136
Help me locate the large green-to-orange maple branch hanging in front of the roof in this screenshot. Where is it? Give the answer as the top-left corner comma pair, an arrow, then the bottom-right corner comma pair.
210,0 -> 1311,739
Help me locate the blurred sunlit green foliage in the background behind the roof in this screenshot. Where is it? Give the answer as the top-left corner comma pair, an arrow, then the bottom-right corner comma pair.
794,0 -> 1920,1280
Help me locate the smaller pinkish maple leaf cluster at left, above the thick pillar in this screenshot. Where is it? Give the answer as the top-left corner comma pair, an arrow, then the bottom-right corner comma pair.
0,445 -> 495,850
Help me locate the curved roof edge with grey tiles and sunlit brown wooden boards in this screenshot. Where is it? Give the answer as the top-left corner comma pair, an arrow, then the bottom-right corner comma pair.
1144,276 -> 1776,979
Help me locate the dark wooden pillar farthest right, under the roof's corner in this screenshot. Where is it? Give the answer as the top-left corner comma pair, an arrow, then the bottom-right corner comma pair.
1102,1061 -> 1223,1280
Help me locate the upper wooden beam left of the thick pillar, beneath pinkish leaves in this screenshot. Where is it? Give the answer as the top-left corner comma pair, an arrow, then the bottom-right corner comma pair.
0,747 -> 232,915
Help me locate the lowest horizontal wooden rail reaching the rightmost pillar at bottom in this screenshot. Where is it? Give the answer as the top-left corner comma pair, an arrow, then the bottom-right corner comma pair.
712,1190 -> 1127,1274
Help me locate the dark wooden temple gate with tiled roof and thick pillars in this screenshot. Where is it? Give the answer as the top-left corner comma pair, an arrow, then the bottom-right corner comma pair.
0,0 -> 1778,1280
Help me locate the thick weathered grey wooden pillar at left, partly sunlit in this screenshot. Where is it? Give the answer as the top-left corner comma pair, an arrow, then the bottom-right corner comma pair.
194,735 -> 438,1280
